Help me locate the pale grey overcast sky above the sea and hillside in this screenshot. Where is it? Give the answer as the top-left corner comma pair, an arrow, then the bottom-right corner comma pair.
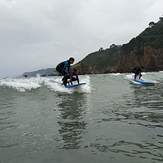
0,0 -> 163,77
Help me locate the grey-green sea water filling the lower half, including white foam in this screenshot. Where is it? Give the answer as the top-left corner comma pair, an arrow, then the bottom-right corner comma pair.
0,72 -> 163,163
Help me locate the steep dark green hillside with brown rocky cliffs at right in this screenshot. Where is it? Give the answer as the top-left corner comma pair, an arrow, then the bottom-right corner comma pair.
75,17 -> 163,74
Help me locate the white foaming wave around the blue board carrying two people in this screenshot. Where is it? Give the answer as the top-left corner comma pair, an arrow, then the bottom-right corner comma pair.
0,76 -> 91,93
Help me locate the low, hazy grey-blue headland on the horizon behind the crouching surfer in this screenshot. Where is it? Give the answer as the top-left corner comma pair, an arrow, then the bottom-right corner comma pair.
23,68 -> 58,77
